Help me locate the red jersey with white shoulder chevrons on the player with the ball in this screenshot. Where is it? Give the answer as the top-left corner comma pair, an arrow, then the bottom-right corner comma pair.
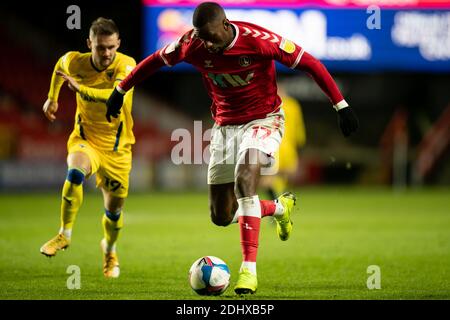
158,21 -> 303,125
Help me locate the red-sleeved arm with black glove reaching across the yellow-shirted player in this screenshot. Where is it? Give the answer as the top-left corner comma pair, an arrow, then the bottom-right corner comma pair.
106,52 -> 165,122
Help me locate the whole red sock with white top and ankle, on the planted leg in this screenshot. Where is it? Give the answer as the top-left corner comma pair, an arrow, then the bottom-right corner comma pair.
237,195 -> 261,275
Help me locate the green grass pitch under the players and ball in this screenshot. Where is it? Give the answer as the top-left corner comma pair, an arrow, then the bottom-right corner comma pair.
0,187 -> 450,300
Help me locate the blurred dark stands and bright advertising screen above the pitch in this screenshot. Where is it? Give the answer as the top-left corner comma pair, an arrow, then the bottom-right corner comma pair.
0,0 -> 450,192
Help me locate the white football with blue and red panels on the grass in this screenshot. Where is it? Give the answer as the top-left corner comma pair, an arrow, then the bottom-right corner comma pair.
189,256 -> 230,296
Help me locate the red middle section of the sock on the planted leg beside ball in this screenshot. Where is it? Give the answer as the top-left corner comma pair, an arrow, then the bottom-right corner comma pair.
239,216 -> 261,262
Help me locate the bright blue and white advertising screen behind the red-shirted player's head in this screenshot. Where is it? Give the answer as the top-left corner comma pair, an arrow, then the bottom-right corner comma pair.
143,0 -> 450,72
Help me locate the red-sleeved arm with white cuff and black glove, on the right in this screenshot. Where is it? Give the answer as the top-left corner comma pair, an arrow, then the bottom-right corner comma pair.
297,52 -> 359,137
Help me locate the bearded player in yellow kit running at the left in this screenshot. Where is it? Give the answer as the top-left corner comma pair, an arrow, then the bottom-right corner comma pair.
40,18 -> 136,278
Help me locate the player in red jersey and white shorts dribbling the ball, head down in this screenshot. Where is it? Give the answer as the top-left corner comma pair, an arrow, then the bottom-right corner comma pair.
106,2 -> 358,294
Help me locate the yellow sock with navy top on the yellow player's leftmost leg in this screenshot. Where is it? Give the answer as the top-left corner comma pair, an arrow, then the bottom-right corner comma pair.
60,168 -> 85,239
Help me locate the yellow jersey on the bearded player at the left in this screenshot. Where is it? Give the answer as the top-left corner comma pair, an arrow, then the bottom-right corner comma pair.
48,51 -> 136,151
